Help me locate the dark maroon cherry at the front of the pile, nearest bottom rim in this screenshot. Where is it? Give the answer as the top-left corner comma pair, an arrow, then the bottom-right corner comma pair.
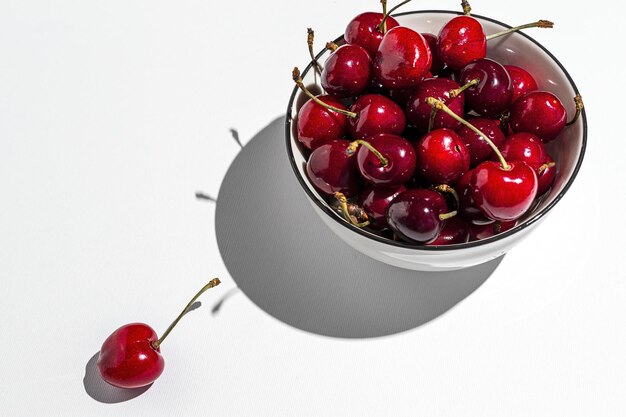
387,188 -> 447,243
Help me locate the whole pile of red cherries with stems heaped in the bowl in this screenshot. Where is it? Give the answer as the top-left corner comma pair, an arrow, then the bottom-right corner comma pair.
293,0 -> 582,245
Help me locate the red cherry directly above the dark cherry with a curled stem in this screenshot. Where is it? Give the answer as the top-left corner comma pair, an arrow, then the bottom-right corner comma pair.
348,94 -> 406,139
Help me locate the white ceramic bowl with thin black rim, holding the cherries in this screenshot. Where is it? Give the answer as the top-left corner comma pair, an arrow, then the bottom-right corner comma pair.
286,10 -> 587,271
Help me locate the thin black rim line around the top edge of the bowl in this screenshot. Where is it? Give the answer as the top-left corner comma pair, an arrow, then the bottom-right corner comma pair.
285,10 -> 587,252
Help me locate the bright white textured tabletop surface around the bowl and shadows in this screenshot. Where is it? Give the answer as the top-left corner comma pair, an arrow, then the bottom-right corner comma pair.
0,0 -> 626,416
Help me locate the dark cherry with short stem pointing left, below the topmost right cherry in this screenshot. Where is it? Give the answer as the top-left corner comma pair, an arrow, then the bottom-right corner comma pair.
459,58 -> 513,117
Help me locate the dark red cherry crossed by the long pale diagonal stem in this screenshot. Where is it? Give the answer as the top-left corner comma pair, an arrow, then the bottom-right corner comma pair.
456,117 -> 506,167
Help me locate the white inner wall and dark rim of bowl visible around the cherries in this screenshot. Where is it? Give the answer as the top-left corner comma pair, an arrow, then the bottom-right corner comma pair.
287,11 -> 587,250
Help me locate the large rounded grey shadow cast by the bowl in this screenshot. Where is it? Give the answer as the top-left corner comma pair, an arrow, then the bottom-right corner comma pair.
215,117 -> 502,338
